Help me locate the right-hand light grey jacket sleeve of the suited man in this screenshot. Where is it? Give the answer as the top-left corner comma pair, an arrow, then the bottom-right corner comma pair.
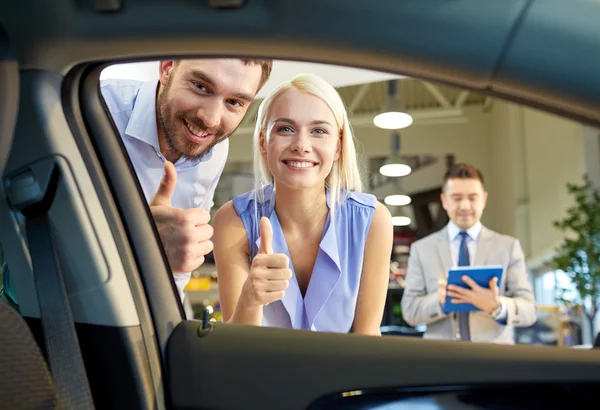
496,239 -> 537,327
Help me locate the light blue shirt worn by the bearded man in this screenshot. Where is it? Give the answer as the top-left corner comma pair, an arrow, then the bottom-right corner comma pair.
100,79 -> 229,300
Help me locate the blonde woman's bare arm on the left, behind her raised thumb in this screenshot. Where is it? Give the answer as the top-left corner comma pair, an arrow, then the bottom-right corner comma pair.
213,201 -> 262,326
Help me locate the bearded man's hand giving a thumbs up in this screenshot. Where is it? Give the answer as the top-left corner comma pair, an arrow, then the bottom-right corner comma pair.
150,162 -> 213,273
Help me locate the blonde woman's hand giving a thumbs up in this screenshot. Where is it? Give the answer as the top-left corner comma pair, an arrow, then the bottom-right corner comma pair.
240,216 -> 292,307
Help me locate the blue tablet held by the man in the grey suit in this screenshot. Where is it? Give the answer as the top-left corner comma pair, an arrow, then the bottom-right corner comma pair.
443,265 -> 504,313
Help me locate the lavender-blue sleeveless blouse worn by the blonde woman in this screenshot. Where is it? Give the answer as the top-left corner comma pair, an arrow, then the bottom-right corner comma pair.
233,185 -> 377,333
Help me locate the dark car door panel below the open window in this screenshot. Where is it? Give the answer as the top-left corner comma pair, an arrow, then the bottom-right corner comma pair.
167,321 -> 600,410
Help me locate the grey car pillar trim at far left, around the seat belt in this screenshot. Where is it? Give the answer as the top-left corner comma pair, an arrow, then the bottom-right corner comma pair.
0,69 -> 168,408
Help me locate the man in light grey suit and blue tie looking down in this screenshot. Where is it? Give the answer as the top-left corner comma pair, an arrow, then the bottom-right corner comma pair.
402,164 -> 537,344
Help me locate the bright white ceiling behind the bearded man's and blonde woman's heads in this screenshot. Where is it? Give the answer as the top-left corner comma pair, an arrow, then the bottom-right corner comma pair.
100,60 -> 401,98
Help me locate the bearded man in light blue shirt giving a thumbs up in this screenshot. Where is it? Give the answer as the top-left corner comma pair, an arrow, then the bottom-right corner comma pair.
101,59 -> 272,299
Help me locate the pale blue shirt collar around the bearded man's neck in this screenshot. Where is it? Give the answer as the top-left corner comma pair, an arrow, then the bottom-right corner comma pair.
125,79 -> 213,165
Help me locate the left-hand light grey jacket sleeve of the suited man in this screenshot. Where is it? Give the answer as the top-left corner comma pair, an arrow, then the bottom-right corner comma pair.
401,245 -> 447,326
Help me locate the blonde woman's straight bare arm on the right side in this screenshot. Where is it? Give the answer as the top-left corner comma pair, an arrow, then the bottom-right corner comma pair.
352,202 -> 394,335
